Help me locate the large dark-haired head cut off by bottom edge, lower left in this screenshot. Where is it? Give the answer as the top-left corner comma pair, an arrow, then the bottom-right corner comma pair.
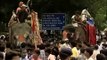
5,52 -> 20,60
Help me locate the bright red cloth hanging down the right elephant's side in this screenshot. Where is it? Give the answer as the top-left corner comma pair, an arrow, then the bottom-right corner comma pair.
86,24 -> 96,45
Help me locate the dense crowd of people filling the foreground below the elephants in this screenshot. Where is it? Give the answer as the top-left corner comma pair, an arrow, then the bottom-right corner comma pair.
0,30 -> 107,60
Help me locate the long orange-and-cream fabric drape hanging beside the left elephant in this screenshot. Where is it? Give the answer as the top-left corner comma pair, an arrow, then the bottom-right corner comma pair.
31,11 -> 42,45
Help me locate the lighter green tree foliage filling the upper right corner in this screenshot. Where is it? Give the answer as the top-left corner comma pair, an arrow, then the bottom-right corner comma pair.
90,0 -> 107,30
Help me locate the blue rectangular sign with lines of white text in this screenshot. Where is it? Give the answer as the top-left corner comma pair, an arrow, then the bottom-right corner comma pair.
42,13 -> 66,30
